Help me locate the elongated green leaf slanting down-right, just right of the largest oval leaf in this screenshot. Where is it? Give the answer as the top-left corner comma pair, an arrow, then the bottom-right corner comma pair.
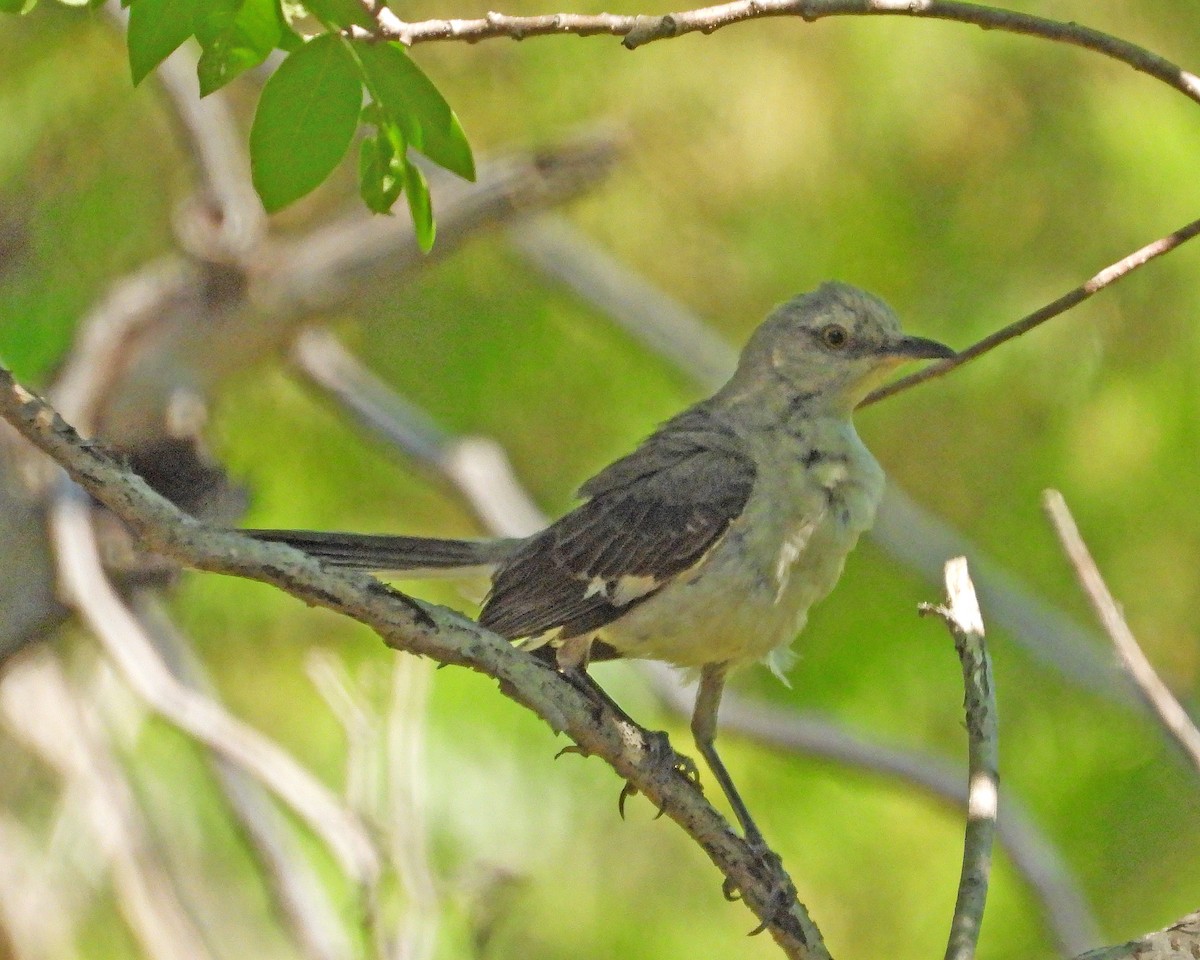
354,41 -> 475,180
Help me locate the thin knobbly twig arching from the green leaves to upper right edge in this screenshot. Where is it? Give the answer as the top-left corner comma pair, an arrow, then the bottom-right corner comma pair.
352,0 -> 1200,111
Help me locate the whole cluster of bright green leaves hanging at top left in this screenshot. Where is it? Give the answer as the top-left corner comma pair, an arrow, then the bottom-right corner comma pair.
120,0 -> 475,234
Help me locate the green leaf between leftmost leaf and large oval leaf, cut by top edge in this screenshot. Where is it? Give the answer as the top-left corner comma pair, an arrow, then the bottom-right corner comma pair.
196,0 -> 283,96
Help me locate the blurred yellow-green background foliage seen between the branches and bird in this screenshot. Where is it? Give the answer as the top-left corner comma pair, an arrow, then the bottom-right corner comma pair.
0,0 -> 1200,960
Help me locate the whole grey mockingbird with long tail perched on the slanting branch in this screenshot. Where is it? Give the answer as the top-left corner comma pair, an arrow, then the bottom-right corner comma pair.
248,283 -> 954,846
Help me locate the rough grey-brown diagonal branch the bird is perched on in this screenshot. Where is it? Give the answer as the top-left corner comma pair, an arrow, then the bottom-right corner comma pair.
0,367 -> 828,960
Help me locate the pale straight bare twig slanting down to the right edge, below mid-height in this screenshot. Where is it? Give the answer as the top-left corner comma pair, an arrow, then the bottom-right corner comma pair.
1043,490 -> 1200,774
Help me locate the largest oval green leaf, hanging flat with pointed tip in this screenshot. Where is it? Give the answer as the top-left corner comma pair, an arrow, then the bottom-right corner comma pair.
250,35 -> 362,212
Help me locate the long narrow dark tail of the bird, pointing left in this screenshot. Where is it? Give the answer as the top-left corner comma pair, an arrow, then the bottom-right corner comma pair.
239,530 -> 522,577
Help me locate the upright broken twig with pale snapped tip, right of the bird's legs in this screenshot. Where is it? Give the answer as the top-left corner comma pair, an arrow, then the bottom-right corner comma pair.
920,557 -> 1000,960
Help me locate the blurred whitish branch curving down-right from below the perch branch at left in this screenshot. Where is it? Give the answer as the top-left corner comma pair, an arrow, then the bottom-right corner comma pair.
50,480 -> 379,887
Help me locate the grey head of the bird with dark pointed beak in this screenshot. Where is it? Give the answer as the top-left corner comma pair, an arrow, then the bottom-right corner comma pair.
730,282 -> 954,414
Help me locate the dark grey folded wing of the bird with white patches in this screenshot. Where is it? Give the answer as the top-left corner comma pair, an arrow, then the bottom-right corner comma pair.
480,407 -> 755,640
